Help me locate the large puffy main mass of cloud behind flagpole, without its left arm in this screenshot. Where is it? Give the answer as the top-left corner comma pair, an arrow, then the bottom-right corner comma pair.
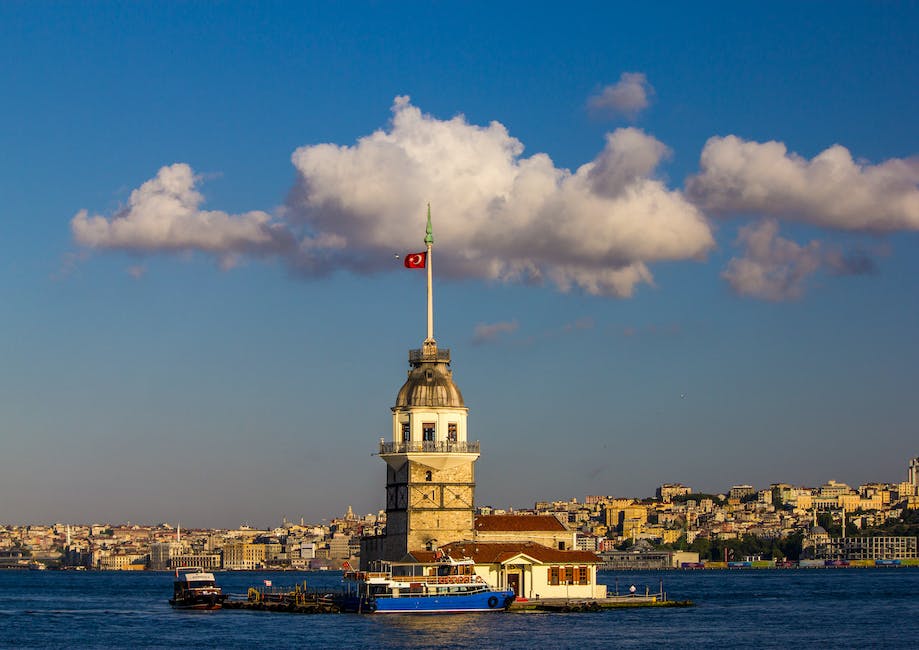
286,97 -> 714,296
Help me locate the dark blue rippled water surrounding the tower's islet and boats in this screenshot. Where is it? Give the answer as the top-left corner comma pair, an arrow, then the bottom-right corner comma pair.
0,568 -> 919,650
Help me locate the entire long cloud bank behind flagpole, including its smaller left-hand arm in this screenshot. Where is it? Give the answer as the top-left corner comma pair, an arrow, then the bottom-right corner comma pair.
71,97 -> 714,297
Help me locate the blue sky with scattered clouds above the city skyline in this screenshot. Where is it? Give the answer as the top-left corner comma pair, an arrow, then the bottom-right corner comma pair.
0,2 -> 919,527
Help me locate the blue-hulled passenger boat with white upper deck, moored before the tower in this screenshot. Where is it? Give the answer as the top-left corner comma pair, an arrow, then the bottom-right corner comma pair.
342,555 -> 514,614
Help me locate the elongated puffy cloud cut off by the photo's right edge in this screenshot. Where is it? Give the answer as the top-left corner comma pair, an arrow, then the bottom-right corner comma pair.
686,135 -> 919,232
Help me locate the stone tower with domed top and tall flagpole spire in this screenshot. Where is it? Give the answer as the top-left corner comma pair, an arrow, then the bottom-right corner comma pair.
361,205 -> 479,569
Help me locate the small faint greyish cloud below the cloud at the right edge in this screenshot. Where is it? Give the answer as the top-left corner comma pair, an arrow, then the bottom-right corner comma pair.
721,219 -> 822,302
